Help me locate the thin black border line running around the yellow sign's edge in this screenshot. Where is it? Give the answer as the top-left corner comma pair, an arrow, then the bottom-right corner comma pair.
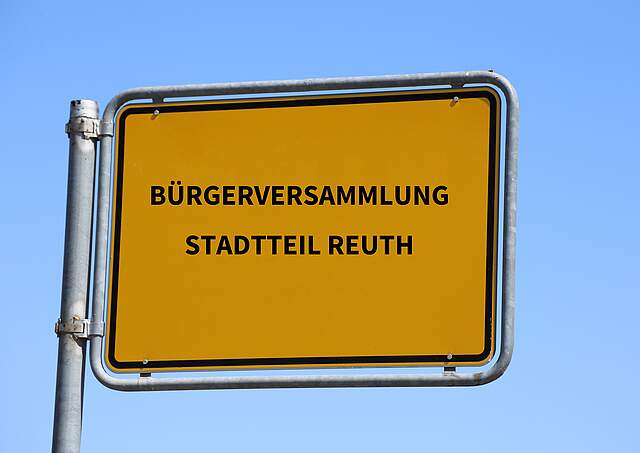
107,87 -> 499,371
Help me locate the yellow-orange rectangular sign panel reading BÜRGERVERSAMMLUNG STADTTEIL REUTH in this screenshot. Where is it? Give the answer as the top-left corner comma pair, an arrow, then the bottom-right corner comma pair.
106,87 -> 500,372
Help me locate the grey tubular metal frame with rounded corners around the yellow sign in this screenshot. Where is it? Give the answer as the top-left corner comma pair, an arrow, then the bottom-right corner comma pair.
86,71 -> 519,391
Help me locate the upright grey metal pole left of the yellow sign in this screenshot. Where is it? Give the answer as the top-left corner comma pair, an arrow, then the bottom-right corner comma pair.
51,100 -> 98,453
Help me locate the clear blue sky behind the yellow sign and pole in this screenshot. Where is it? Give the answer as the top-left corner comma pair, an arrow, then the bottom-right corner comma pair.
0,0 -> 640,453
